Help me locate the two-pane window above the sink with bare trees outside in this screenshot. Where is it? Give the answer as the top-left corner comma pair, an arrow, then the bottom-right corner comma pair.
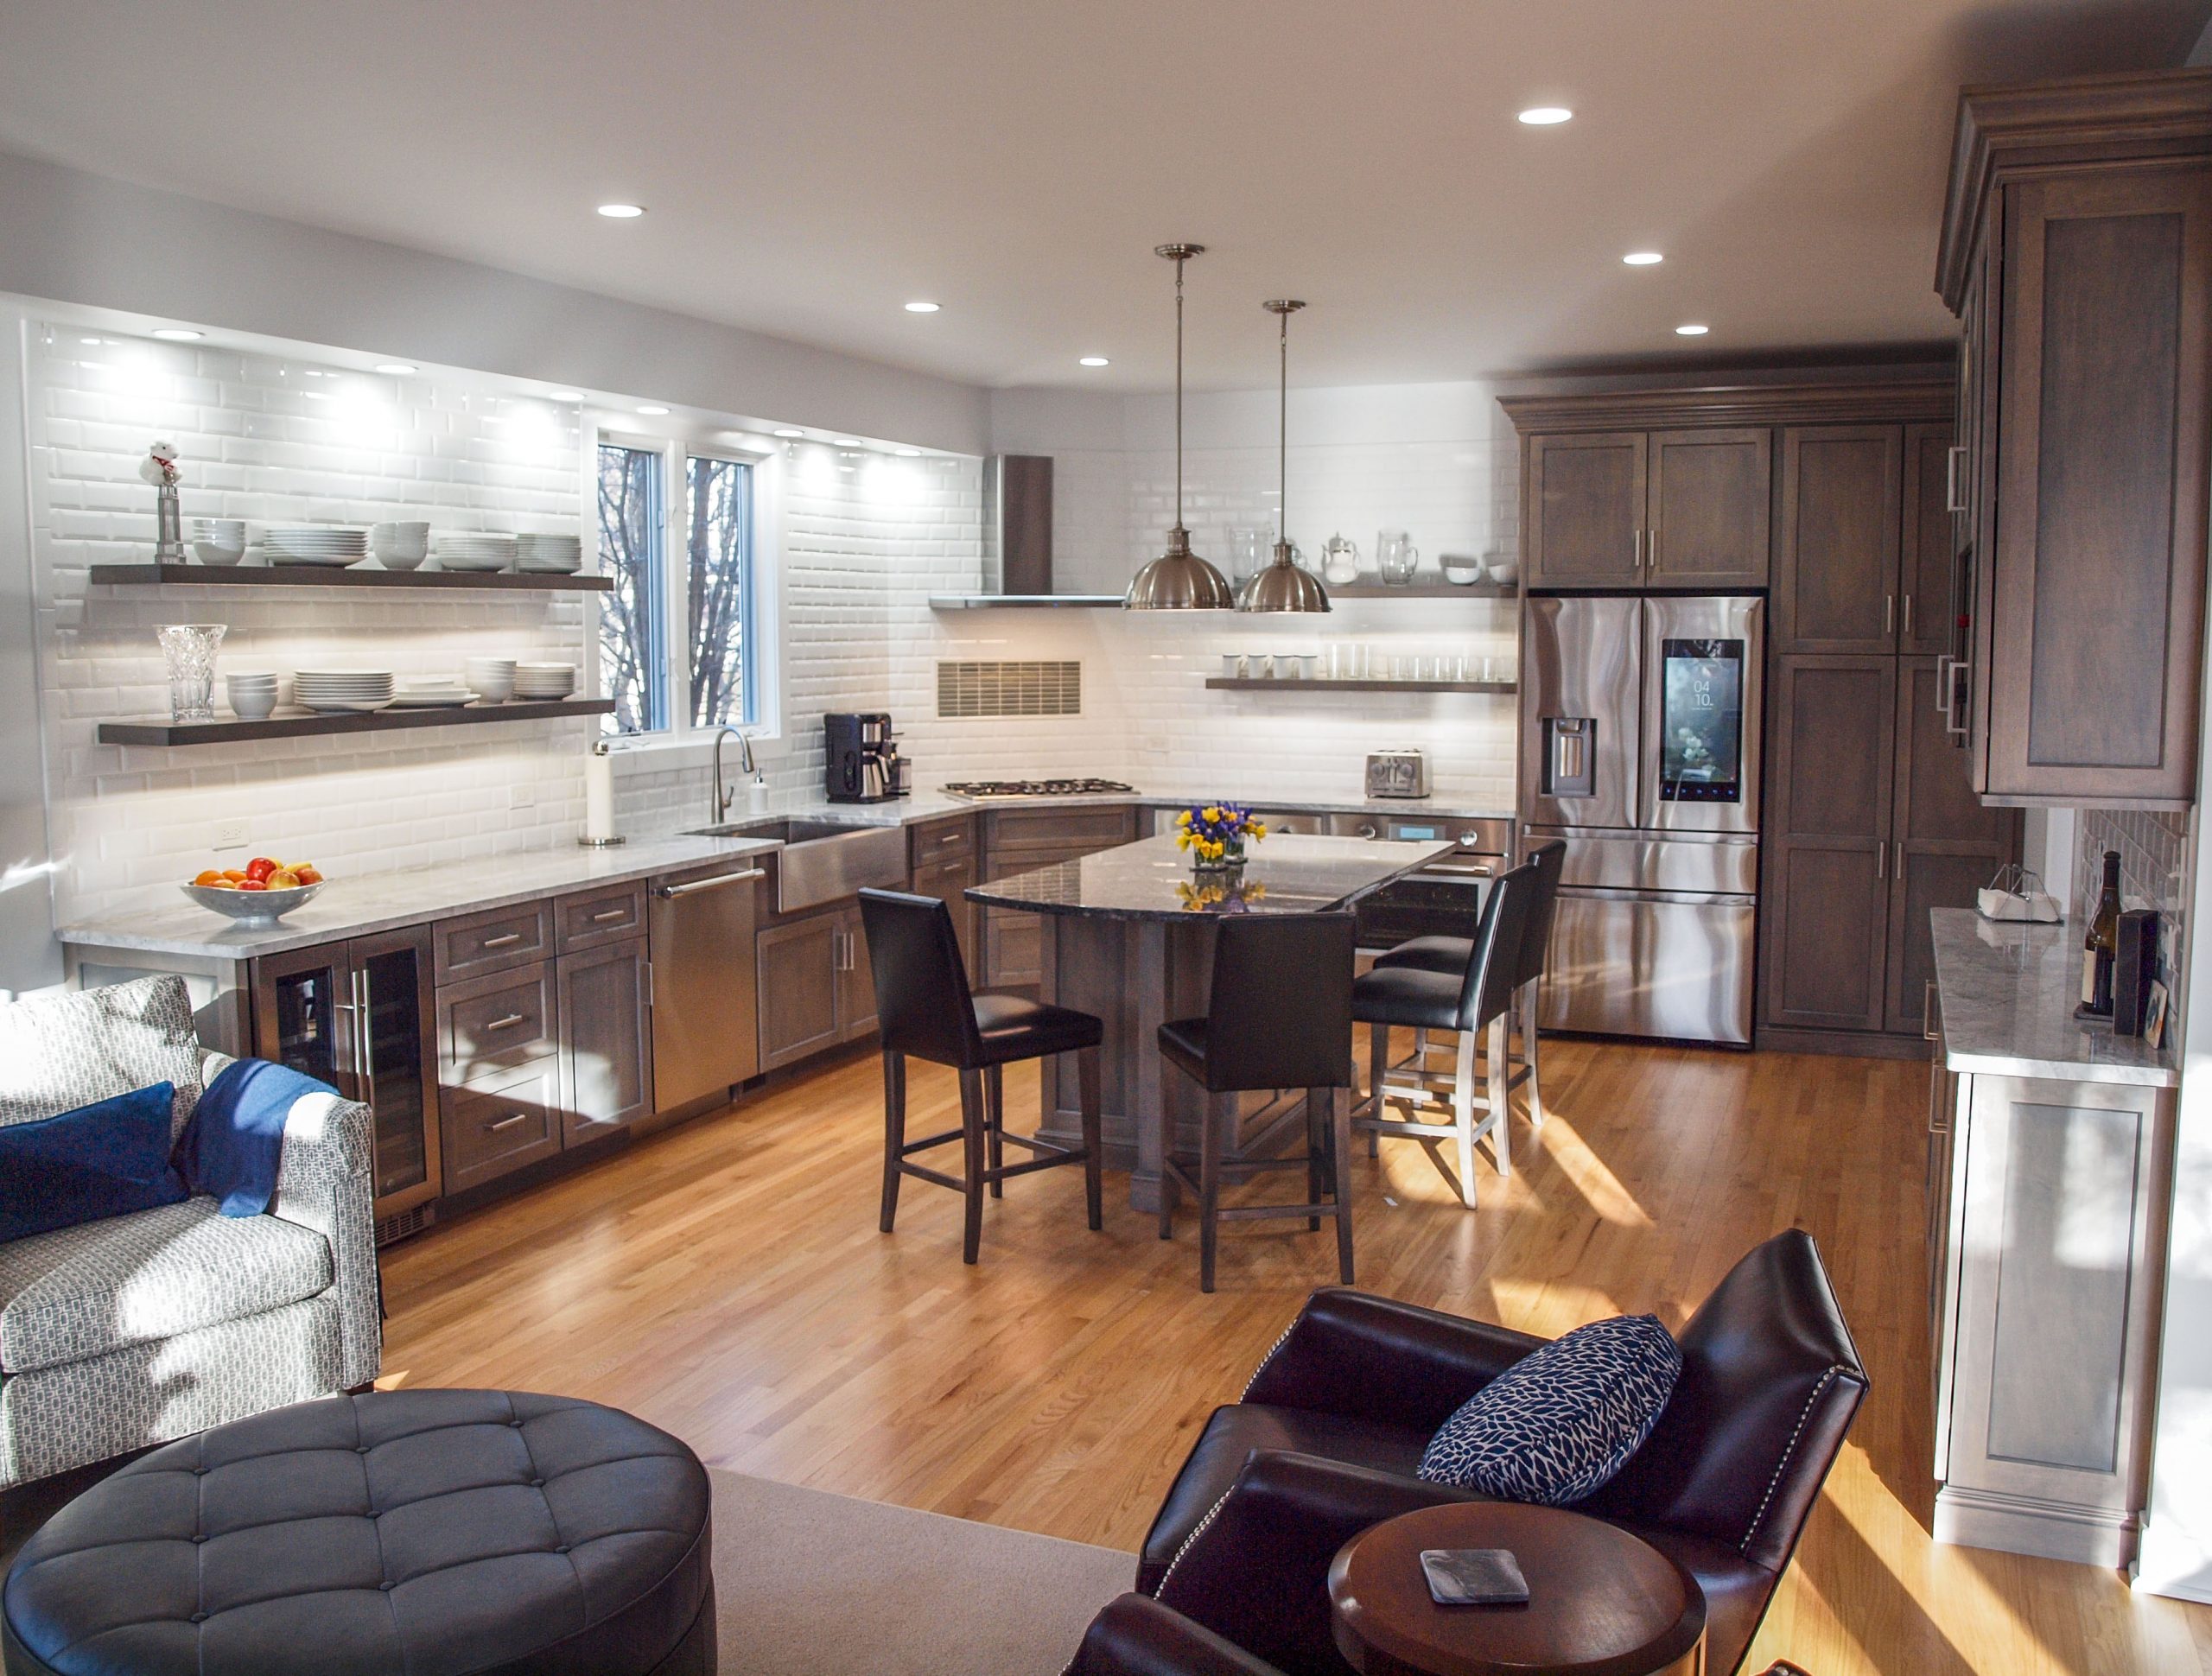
597,438 -> 767,736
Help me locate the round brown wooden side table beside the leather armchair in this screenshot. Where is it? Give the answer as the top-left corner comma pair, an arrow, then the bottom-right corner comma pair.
1330,1501 -> 1706,1676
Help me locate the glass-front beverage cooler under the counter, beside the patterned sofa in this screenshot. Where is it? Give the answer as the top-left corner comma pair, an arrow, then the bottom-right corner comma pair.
254,926 -> 440,1216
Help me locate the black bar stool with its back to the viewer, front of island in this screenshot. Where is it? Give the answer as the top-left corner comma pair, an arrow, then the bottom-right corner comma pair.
1159,913 -> 1356,1292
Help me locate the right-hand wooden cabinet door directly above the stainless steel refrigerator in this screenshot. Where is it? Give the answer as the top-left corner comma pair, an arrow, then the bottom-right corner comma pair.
1643,427 -> 1774,588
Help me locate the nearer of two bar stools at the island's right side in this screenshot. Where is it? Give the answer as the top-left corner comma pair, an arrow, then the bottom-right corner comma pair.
1351,862 -> 1537,1209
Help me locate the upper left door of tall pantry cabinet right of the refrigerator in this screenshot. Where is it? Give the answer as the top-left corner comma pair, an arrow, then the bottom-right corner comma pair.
1772,424 -> 1904,655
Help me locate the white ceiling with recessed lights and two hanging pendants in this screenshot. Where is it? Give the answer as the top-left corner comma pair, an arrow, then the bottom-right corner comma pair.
0,0 -> 2212,389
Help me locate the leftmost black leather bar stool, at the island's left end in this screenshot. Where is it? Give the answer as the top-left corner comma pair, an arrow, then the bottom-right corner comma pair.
861,891 -> 1103,1262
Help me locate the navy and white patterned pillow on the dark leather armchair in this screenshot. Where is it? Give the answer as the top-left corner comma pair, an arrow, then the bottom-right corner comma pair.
1421,1316 -> 1681,1508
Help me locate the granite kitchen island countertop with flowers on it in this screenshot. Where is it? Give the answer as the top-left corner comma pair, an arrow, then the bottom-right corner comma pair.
967,831 -> 1451,920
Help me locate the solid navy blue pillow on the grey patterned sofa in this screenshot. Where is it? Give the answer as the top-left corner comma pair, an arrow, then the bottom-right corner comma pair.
0,1083 -> 188,1241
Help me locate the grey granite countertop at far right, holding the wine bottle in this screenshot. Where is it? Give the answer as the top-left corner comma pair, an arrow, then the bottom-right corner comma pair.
1931,909 -> 2181,1088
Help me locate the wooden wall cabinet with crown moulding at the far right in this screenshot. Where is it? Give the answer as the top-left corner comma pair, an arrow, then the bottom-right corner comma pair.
1938,71 -> 2212,809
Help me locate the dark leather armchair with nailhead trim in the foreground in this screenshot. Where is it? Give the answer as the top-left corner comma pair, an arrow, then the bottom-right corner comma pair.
1137,1229 -> 1867,1676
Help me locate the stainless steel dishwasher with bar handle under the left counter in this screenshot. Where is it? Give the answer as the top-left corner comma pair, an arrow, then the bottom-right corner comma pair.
646,858 -> 767,1112
